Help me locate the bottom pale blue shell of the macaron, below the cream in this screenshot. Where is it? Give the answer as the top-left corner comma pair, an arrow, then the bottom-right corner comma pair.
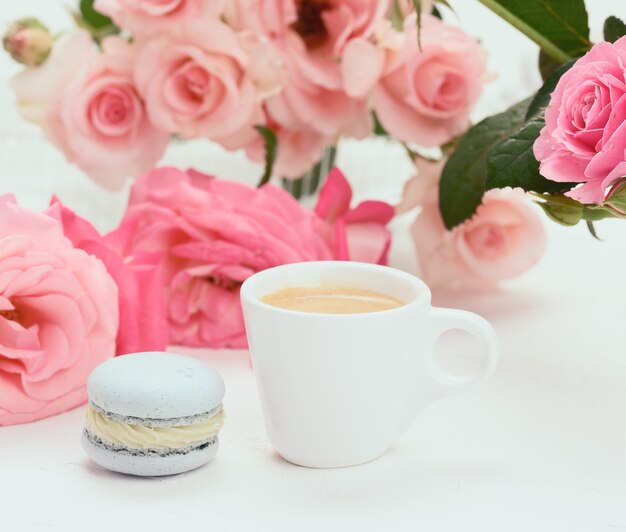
82,433 -> 219,477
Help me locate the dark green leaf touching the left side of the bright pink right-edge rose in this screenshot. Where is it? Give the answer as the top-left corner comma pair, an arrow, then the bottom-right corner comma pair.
487,114 -> 576,194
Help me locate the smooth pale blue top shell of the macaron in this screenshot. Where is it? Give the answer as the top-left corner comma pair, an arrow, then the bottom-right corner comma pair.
87,352 -> 224,419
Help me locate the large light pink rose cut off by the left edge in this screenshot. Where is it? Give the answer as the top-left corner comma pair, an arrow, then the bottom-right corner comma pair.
0,196 -> 118,425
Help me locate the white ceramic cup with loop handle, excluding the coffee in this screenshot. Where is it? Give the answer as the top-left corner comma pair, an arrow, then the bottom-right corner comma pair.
241,261 -> 498,468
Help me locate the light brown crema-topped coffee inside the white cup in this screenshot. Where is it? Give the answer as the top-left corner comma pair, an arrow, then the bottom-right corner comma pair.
261,285 -> 406,314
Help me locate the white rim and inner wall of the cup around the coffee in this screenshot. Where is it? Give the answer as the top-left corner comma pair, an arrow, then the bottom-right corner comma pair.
240,260 -> 431,319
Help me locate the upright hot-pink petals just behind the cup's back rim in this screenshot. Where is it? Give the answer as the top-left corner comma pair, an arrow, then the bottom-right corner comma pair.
315,168 -> 395,264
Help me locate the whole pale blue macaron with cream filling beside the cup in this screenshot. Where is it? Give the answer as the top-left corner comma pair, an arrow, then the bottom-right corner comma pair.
82,352 -> 224,476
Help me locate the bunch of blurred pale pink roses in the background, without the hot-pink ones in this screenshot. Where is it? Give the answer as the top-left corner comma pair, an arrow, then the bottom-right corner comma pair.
5,0 -> 544,286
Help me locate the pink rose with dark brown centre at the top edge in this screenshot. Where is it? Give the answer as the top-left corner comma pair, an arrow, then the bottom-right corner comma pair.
251,0 -> 389,139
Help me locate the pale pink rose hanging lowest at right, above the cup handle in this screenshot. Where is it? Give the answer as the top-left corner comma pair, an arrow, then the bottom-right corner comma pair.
411,189 -> 546,287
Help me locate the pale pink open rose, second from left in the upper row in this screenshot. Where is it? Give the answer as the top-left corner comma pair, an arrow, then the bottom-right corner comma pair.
135,19 -> 282,149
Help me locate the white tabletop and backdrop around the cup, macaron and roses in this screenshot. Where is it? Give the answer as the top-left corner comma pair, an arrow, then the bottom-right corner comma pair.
0,0 -> 626,532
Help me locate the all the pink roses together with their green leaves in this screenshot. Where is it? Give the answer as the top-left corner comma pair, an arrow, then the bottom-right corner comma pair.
0,0 -> 626,425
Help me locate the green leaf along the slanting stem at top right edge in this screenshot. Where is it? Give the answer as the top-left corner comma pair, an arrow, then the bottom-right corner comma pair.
480,0 -> 591,63
